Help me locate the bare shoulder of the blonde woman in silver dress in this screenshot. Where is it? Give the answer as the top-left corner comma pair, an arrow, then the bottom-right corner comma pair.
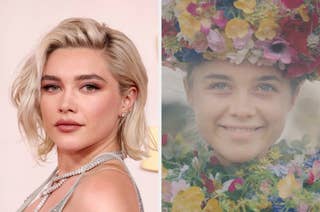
70,163 -> 139,212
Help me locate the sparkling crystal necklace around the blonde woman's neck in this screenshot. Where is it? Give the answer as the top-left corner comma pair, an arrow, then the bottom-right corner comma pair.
34,152 -> 123,212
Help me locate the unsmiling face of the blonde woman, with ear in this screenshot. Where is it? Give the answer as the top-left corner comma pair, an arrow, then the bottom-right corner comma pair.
40,48 -> 133,152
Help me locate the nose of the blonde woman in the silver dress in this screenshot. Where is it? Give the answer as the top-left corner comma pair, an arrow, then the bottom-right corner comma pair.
58,90 -> 77,113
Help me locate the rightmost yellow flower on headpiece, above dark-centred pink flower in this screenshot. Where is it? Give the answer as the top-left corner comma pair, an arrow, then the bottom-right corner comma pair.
255,19 -> 279,40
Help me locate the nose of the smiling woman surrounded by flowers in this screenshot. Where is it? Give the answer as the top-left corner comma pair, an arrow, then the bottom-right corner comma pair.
229,92 -> 256,119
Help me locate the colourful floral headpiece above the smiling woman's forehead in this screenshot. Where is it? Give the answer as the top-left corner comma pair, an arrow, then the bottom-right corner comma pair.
162,0 -> 320,80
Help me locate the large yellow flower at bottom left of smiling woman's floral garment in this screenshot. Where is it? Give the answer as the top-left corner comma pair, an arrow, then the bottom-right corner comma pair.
172,186 -> 204,212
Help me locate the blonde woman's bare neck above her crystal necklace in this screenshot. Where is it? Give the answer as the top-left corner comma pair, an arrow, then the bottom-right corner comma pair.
57,139 -> 121,174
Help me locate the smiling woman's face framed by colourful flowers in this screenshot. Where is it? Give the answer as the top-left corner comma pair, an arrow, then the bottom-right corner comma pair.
185,62 -> 296,165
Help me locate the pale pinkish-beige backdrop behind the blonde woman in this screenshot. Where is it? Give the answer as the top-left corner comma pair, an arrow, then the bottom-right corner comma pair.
0,0 -> 160,212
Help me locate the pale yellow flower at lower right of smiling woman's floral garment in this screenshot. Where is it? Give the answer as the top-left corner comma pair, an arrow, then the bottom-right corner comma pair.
277,174 -> 301,199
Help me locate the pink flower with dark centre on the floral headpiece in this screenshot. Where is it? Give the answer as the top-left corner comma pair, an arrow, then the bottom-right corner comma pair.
257,39 -> 297,64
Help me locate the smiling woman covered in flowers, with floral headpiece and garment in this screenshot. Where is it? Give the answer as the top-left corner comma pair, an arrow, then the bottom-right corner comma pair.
162,0 -> 320,211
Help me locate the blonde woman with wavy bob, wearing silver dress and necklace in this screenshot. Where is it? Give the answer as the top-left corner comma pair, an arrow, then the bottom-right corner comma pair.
12,18 -> 150,211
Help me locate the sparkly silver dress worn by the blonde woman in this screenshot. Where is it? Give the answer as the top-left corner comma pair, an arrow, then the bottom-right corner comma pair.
17,153 -> 144,212
